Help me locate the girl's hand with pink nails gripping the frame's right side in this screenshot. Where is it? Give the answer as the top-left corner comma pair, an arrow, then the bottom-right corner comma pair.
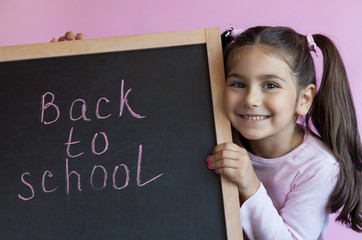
206,143 -> 260,202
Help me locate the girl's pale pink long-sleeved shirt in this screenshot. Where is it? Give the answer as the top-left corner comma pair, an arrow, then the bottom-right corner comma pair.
236,126 -> 339,240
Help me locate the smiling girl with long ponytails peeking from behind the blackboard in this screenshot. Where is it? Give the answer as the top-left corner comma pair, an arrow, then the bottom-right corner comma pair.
207,27 -> 362,240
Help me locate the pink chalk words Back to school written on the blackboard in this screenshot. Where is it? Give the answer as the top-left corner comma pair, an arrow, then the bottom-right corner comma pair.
18,79 -> 164,201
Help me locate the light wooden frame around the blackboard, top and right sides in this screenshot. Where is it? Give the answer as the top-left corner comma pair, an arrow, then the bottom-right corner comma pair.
0,28 -> 243,240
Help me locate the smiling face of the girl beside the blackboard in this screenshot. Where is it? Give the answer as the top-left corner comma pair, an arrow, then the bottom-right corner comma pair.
224,46 -> 298,143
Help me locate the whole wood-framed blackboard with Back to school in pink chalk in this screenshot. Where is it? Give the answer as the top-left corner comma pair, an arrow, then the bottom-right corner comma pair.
0,29 -> 241,239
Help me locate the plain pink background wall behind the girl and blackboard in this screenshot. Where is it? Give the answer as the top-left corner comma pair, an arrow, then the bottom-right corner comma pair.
0,0 -> 362,240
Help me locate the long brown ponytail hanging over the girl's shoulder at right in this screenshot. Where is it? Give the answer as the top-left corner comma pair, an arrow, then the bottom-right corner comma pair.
306,34 -> 362,232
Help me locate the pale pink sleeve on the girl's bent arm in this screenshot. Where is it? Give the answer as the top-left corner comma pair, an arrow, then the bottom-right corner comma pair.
240,165 -> 338,240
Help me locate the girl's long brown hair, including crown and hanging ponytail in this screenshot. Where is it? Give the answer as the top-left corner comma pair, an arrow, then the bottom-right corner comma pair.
222,27 -> 362,232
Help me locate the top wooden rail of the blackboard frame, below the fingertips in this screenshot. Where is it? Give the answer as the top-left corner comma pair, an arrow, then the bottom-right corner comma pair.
0,28 -> 217,62
